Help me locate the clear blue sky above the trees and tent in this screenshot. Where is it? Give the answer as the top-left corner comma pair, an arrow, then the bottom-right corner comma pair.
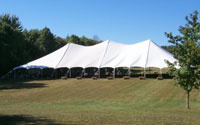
0,0 -> 200,45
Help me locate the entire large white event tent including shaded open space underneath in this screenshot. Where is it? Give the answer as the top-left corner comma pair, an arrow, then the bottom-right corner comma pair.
10,40 -> 175,78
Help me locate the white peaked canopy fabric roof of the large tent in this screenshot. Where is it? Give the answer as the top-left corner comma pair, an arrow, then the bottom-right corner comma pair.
14,40 -> 175,69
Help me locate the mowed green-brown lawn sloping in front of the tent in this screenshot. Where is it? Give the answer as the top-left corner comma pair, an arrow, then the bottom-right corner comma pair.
0,78 -> 200,125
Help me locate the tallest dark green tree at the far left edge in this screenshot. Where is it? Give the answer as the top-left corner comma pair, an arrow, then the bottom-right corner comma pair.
0,14 -> 28,75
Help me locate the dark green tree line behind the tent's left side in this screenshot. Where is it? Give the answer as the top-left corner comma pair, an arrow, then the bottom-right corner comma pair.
0,14 -> 98,76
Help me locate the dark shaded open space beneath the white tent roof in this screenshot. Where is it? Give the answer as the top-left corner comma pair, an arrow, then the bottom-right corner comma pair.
6,67 -> 169,80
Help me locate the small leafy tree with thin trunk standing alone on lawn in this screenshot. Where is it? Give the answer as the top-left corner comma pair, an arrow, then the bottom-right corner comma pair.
165,11 -> 200,109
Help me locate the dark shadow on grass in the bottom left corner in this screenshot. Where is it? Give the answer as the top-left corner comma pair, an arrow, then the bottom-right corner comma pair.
0,114 -> 61,125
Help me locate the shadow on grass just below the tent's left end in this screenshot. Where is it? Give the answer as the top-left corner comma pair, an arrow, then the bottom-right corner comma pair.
0,81 -> 47,90
